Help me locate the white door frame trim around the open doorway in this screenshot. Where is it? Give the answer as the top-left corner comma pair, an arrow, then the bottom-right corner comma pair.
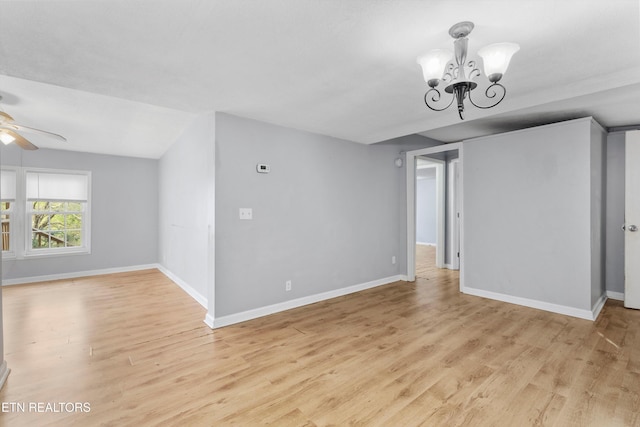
405,142 -> 464,289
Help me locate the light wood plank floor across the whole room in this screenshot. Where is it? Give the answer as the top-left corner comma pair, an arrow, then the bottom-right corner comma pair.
0,252 -> 640,426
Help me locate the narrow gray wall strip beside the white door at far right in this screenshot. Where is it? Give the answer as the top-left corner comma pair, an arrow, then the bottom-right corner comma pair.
605,132 -> 625,294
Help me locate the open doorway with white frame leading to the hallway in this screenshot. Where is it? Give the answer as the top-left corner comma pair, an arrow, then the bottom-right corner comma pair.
406,143 -> 463,288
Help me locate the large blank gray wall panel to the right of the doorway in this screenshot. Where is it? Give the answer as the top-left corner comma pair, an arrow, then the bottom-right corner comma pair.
462,119 -> 600,310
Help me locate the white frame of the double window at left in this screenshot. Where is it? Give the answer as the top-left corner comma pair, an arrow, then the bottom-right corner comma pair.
2,166 -> 92,260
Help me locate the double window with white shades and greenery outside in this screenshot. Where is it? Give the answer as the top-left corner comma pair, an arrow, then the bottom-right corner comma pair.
1,168 -> 91,258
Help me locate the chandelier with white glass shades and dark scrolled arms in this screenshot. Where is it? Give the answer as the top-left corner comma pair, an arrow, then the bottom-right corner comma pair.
418,21 -> 520,120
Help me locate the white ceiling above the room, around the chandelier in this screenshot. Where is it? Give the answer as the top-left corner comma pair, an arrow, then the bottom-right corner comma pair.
0,0 -> 640,158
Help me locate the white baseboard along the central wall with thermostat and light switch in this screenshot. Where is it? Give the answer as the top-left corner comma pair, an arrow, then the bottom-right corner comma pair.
212,275 -> 402,328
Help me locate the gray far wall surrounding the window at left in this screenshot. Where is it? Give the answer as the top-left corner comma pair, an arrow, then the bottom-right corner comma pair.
0,145 -> 158,280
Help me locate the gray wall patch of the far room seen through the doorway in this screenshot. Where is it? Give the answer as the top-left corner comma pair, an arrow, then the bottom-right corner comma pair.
416,168 -> 436,245
